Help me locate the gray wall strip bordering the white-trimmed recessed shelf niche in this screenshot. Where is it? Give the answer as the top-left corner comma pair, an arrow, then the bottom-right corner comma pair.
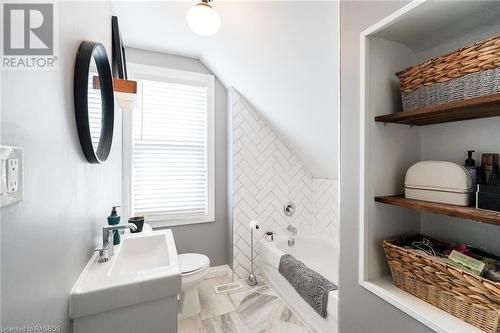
339,1 -> 431,333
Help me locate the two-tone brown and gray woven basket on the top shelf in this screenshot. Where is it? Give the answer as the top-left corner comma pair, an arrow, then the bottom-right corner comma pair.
396,36 -> 500,111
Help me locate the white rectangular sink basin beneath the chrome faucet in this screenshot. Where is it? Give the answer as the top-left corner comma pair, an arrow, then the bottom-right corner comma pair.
70,230 -> 181,319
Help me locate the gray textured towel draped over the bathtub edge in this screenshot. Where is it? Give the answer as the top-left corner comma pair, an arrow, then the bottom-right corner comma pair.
278,254 -> 338,318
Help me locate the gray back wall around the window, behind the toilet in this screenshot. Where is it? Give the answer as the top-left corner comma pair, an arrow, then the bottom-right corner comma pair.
126,48 -> 232,266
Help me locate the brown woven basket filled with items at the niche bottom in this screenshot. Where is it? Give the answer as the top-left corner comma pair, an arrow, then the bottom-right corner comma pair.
383,237 -> 500,333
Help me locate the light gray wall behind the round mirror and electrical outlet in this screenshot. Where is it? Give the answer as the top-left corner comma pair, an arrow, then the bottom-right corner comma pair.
1,2 -> 122,332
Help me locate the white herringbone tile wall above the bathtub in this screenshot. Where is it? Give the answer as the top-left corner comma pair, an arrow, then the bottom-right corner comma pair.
231,89 -> 338,278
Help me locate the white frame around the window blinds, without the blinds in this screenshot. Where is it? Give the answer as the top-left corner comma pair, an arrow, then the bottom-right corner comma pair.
122,63 -> 215,227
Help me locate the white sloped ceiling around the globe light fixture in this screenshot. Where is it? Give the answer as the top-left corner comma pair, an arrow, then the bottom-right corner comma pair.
113,1 -> 340,179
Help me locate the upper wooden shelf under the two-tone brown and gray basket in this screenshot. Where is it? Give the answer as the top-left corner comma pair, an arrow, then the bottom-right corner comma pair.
375,94 -> 500,126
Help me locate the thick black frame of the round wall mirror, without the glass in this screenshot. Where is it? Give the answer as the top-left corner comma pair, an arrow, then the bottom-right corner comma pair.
73,41 -> 115,163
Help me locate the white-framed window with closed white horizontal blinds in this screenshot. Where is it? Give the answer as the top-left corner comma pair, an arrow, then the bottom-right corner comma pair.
123,64 -> 215,226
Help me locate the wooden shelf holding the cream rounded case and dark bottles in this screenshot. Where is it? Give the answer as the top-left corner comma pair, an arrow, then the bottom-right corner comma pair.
375,195 -> 500,225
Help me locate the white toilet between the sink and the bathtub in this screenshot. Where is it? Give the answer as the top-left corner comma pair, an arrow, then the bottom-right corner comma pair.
178,253 -> 210,318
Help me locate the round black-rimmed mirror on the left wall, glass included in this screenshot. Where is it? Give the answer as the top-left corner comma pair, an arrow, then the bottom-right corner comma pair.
73,41 -> 115,163
